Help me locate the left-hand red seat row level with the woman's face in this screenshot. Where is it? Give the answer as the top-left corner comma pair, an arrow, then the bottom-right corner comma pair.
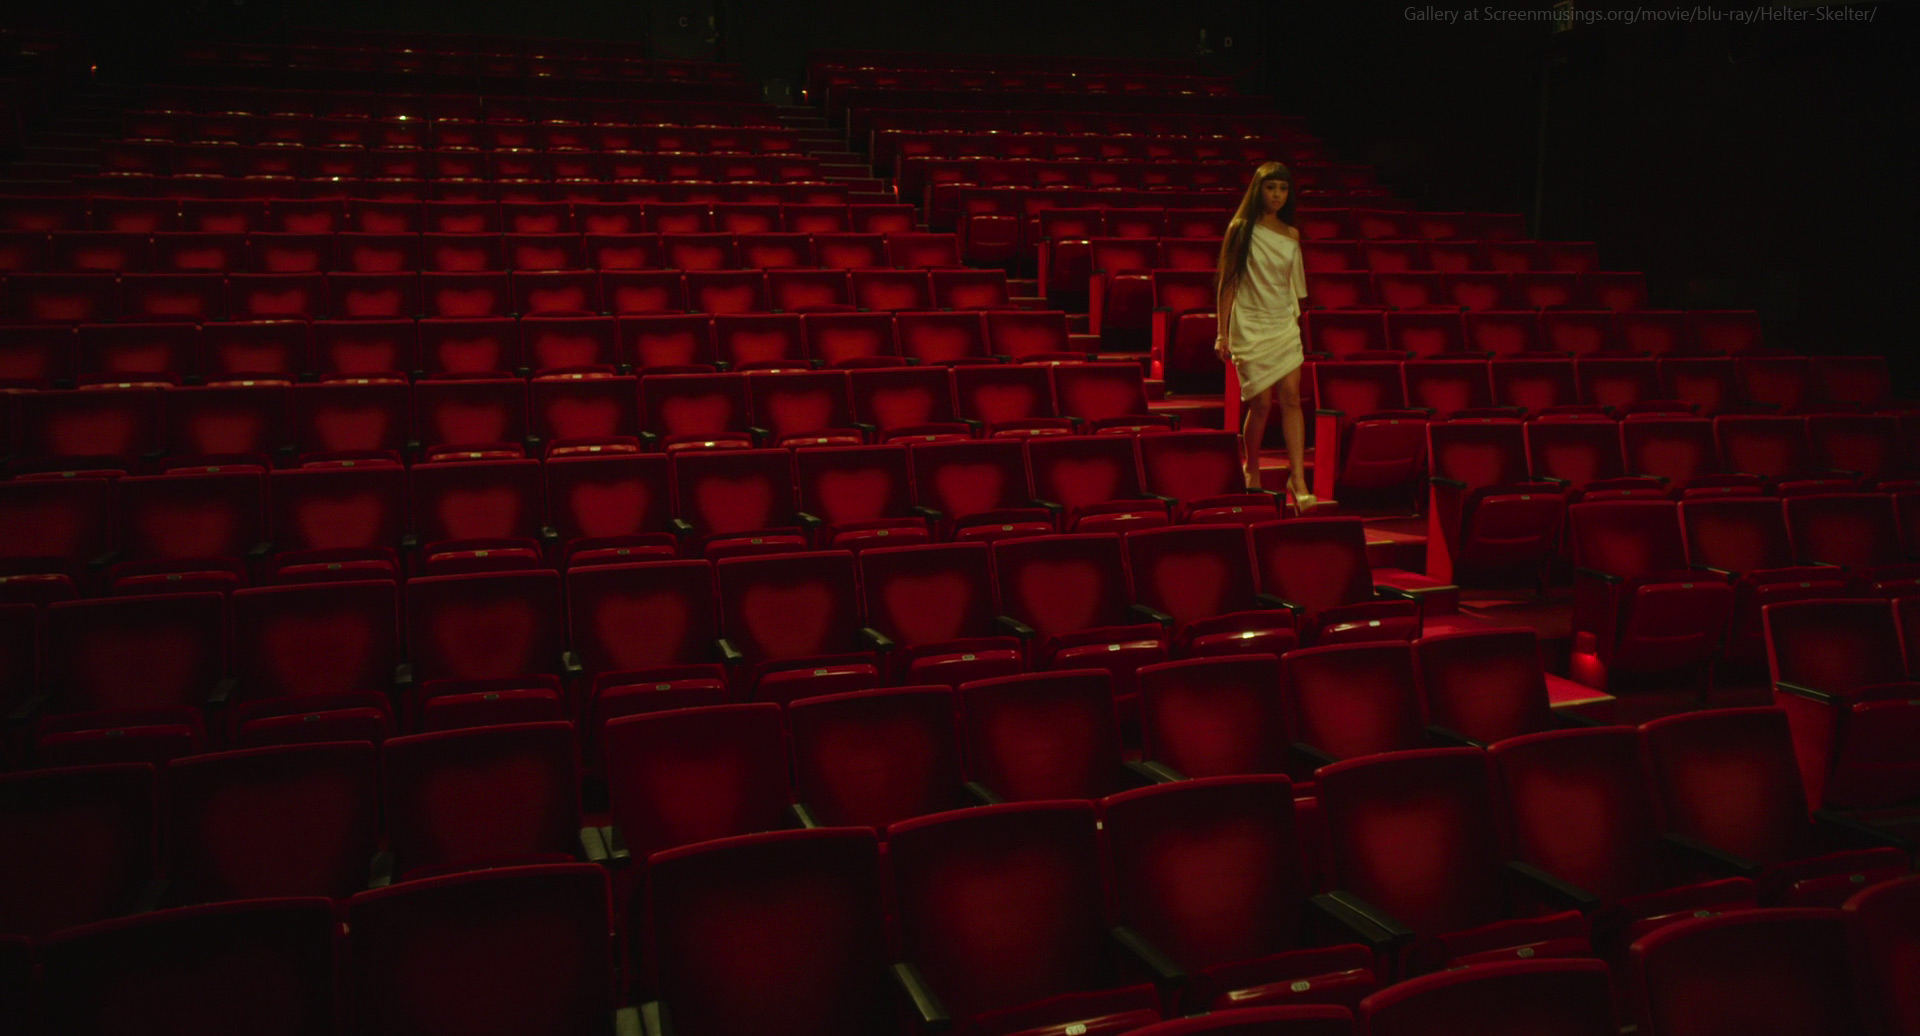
0,196 -> 914,234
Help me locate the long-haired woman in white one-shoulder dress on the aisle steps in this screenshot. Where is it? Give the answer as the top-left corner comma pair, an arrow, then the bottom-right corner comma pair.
1213,161 -> 1315,512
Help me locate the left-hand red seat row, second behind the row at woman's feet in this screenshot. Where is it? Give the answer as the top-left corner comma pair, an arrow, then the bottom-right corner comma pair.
0,306 -> 1105,387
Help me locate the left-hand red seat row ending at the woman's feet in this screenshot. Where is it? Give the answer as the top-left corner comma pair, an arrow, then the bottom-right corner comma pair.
0,434 -> 1320,587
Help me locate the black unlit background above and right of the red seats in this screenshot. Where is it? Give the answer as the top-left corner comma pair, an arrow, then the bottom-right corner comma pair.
13,0 -> 1920,376
